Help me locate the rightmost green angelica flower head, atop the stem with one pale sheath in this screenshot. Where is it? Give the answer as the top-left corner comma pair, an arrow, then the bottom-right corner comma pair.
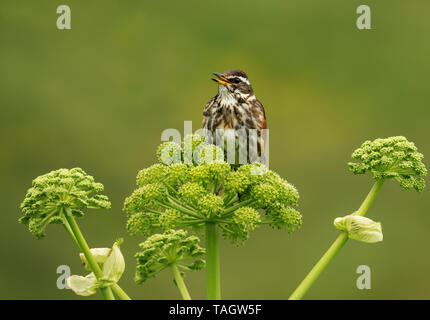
348,136 -> 427,191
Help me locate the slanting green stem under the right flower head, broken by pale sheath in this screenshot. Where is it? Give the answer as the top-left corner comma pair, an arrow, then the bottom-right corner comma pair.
289,180 -> 384,300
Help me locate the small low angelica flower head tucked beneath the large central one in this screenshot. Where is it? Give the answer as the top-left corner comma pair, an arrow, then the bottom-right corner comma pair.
135,230 -> 205,284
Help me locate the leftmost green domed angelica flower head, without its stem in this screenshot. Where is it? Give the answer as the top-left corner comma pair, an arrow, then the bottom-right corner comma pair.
19,168 -> 110,238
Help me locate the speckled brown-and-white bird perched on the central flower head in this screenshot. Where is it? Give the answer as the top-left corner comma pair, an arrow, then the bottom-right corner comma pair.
203,69 -> 267,168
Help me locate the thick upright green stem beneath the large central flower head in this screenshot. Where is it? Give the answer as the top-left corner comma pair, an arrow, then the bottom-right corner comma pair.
206,222 -> 221,300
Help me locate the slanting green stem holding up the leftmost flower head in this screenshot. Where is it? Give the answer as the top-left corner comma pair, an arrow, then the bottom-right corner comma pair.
64,208 -> 115,300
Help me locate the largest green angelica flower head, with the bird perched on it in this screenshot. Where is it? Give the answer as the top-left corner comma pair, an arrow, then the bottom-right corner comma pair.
124,135 -> 302,244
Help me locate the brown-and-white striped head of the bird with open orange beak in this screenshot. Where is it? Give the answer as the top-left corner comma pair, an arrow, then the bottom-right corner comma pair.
212,69 -> 254,96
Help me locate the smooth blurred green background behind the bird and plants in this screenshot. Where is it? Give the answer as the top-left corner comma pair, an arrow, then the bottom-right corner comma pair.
0,0 -> 430,299
